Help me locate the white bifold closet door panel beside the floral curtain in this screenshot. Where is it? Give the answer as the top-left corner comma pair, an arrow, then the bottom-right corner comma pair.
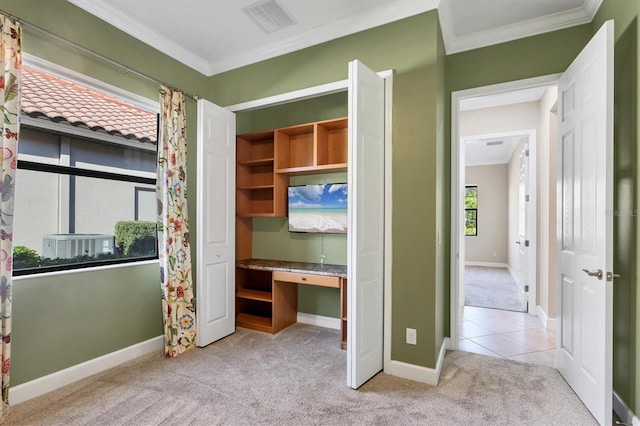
196,99 -> 236,346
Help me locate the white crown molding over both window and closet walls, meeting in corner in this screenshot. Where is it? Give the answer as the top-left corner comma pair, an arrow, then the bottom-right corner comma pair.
67,0 -> 440,76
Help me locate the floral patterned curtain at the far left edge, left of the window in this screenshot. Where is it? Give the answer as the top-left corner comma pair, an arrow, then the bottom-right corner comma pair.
0,15 -> 22,420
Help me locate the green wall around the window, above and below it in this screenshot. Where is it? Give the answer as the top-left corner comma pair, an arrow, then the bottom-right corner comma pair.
0,0 -> 209,386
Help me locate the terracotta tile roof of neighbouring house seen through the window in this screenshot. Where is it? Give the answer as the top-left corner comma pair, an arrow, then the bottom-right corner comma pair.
22,66 -> 157,144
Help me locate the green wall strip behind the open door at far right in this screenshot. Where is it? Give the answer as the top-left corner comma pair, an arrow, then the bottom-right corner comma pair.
592,0 -> 640,415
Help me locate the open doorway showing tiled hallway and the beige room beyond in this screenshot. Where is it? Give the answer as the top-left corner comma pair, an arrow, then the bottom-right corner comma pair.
451,76 -> 557,366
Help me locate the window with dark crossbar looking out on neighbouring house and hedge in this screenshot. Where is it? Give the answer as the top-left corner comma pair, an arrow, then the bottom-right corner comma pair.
13,66 -> 158,275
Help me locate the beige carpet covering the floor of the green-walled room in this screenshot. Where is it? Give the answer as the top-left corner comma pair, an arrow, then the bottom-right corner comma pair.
6,324 -> 596,426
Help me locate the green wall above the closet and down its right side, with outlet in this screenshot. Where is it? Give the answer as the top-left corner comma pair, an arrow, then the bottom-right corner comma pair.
211,11 -> 448,367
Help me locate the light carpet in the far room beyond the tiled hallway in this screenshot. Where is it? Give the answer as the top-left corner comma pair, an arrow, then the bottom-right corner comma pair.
464,266 -> 525,312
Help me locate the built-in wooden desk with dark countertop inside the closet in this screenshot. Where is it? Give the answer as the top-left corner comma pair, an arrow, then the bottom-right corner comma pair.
236,259 -> 347,349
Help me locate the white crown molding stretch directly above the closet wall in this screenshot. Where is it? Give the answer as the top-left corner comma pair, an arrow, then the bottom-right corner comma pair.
208,0 -> 440,75
